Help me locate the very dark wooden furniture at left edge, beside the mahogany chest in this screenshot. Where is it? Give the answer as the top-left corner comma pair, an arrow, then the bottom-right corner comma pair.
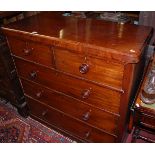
0,31 -> 28,117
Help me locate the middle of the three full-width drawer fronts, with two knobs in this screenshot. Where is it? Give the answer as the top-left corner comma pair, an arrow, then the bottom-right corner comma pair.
21,80 -> 118,134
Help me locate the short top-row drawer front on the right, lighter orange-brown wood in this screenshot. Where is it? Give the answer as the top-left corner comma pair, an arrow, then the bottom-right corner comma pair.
54,48 -> 123,89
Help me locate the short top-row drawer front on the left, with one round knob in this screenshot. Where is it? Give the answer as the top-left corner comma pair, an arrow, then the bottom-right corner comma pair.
8,37 -> 54,67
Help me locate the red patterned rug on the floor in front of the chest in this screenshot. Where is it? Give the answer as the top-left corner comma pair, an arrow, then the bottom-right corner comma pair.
0,99 -> 74,143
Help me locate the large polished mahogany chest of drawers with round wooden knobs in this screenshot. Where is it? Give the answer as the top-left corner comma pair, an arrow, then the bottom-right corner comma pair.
3,12 -> 152,142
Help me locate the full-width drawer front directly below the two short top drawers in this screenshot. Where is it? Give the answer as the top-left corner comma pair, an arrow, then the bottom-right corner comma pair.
15,58 -> 121,113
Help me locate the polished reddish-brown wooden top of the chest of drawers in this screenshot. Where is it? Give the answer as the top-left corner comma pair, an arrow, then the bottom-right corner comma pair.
3,12 -> 152,63
